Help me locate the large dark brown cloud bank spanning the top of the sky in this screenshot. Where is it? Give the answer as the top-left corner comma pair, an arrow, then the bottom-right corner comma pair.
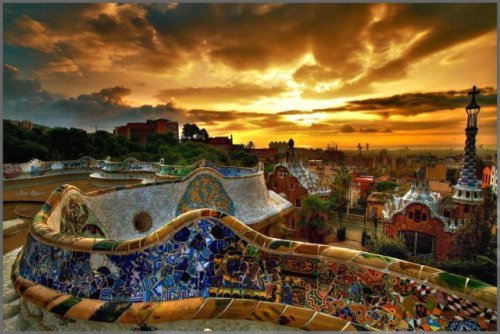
5,3 -> 496,85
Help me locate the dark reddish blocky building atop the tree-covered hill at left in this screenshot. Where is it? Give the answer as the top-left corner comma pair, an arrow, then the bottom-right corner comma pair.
113,119 -> 179,144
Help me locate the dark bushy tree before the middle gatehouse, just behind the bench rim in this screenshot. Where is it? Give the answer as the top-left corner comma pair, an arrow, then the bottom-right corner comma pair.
301,196 -> 327,243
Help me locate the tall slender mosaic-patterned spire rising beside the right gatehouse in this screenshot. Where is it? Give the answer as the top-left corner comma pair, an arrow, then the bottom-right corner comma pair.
452,86 -> 483,209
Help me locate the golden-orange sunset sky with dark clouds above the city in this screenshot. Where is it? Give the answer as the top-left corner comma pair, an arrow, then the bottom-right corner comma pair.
3,4 -> 497,149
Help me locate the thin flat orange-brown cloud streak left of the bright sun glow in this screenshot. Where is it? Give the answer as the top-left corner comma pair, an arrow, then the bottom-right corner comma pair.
156,83 -> 287,104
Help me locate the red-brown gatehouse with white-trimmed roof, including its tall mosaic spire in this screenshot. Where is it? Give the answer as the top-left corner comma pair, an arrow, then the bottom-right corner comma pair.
384,87 -> 484,261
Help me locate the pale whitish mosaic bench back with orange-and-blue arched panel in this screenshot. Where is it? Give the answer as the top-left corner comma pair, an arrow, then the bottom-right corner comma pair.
49,163 -> 292,238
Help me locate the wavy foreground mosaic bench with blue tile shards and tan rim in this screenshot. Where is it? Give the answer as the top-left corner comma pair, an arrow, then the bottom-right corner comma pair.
12,185 -> 497,331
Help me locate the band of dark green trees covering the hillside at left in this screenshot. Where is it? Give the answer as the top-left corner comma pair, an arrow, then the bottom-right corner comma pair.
3,120 -> 258,167
